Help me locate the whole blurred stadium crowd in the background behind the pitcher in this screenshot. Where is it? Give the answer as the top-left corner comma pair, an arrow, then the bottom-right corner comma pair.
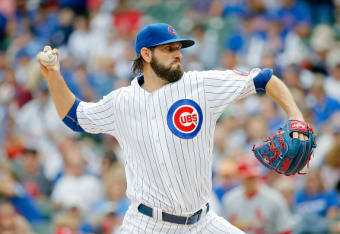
0,0 -> 340,234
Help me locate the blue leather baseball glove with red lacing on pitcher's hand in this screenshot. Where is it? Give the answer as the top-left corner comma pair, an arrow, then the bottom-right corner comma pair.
253,120 -> 316,175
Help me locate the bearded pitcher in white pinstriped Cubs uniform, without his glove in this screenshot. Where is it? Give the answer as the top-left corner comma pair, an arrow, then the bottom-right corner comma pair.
37,24 -> 314,234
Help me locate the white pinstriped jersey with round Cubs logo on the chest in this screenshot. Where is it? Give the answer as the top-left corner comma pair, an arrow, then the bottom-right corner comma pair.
77,69 -> 261,215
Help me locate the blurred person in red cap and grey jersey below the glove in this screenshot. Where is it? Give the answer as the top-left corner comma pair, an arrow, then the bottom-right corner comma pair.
223,157 -> 293,234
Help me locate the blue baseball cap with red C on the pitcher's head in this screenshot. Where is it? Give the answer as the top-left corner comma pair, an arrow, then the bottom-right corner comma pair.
135,24 -> 195,54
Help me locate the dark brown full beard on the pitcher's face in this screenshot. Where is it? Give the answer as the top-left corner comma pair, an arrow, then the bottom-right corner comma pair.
150,56 -> 184,83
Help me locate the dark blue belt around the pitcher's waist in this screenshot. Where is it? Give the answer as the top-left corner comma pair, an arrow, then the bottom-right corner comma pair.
138,203 -> 209,225
